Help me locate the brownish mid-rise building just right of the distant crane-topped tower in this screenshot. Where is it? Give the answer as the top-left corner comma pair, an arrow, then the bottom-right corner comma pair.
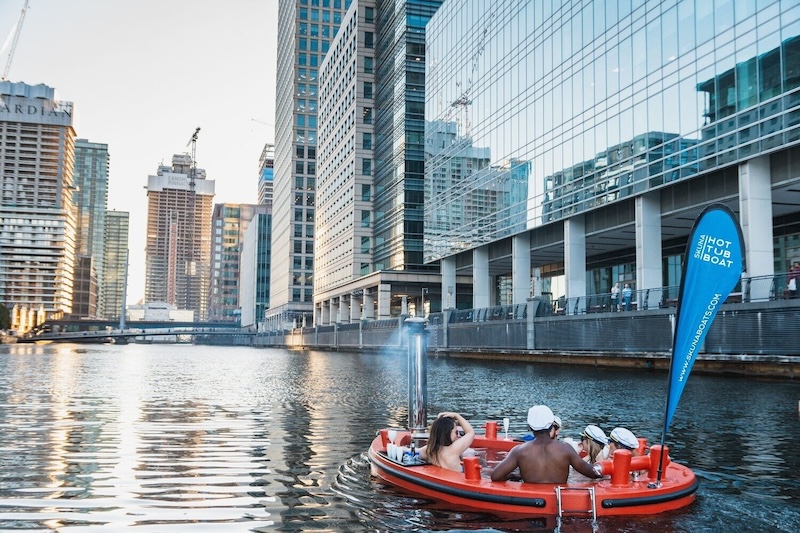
208,204 -> 267,321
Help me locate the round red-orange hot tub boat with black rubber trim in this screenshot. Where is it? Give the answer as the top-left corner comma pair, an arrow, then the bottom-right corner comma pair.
369,430 -> 698,518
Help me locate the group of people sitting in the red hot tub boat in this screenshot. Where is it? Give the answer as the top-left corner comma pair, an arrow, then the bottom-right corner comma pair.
419,405 -> 639,483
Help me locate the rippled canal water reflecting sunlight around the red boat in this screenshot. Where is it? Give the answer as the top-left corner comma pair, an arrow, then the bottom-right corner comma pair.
0,344 -> 800,533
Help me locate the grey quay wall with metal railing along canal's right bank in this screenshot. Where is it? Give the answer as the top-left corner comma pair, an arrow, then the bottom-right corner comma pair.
246,274 -> 800,377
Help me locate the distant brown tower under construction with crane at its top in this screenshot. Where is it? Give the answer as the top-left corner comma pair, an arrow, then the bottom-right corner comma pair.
144,154 -> 214,321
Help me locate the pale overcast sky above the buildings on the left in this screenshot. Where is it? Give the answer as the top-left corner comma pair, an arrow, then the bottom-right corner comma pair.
0,0 -> 278,305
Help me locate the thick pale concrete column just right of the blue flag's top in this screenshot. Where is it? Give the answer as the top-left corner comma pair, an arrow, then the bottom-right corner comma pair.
739,155 -> 775,300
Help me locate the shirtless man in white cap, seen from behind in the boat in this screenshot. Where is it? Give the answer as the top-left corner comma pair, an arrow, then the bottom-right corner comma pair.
492,405 -> 603,484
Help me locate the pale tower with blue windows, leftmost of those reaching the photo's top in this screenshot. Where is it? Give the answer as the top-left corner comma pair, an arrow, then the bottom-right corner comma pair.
267,0 -> 350,328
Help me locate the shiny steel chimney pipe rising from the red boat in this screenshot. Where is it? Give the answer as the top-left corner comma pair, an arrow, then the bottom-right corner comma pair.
405,317 -> 428,437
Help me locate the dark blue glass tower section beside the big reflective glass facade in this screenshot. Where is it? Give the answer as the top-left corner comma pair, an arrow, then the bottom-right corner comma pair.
373,0 -> 442,270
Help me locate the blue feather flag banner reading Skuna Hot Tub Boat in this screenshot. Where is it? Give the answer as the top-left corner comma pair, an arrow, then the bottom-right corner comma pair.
664,204 -> 744,434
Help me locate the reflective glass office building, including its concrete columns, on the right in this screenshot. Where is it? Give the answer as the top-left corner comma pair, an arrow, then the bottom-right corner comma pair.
425,0 -> 800,307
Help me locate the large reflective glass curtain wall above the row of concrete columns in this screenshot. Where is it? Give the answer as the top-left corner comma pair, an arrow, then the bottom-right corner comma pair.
425,0 -> 800,300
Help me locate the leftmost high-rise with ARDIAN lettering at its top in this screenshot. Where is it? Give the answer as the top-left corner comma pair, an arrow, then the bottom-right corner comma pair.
0,81 -> 76,331
